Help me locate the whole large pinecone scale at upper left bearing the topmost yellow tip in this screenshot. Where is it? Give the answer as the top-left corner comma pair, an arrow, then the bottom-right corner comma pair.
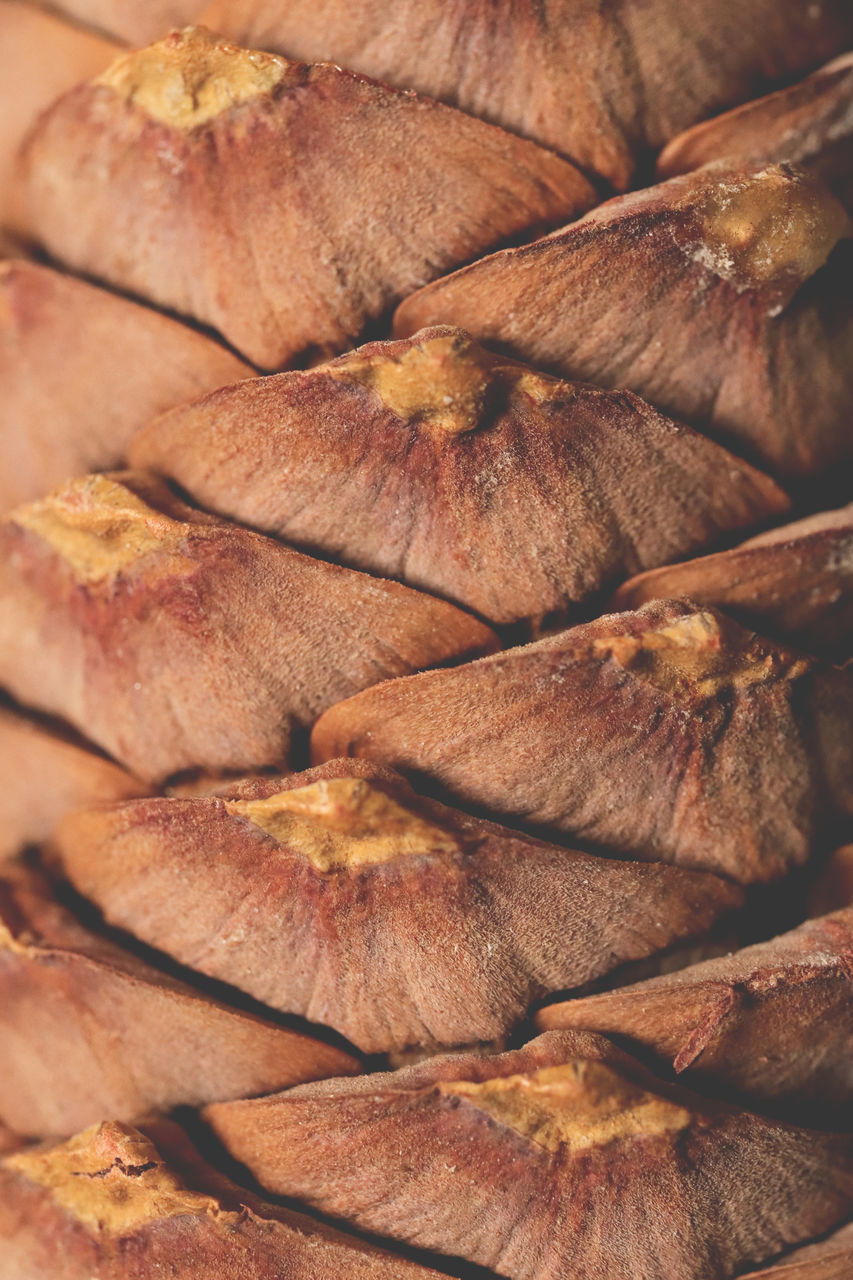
23,28 -> 596,369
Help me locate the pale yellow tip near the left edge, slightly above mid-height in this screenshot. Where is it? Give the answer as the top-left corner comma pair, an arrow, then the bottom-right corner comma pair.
9,476 -> 190,582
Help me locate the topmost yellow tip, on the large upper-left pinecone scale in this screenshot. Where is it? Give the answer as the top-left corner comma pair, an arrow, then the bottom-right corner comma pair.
93,27 -> 286,129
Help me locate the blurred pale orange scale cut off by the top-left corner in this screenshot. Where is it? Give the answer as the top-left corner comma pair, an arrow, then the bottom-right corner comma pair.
0,0 -> 122,225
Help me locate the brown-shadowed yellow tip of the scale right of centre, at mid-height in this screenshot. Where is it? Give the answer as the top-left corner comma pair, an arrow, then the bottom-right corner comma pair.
593,612 -> 811,698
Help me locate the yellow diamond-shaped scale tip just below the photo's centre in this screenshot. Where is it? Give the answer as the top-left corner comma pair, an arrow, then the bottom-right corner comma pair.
224,778 -> 461,872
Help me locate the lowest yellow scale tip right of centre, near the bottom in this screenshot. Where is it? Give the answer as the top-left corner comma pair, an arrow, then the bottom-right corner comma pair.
438,1059 -> 690,1151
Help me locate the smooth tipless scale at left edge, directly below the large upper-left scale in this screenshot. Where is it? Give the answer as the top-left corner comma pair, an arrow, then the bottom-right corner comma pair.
0,261 -> 252,509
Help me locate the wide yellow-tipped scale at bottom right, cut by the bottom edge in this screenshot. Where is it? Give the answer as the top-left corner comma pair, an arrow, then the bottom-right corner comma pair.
206,1032 -> 853,1280
